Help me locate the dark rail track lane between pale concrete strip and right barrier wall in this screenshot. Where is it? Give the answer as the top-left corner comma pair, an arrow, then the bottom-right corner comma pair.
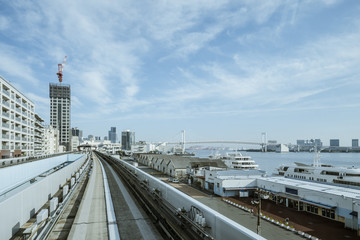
95,152 -> 210,240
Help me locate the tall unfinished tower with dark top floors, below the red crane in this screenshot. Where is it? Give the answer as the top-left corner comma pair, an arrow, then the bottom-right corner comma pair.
50,83 -> 71,151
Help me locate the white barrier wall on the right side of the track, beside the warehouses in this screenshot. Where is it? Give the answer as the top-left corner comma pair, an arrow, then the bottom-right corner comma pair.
118,158 -> 265,240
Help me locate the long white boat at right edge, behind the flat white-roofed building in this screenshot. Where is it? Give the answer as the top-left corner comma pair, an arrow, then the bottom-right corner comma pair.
276,153 -> 360,187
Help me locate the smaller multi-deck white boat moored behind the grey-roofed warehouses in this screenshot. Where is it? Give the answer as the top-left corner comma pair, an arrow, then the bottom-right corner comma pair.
209,151 -> 259,170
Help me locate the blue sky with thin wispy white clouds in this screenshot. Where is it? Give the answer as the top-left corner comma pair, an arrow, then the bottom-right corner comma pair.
0,0 -> 360,146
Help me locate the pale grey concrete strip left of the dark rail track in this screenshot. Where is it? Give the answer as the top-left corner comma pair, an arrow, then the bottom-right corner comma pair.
68,159 -> 108,240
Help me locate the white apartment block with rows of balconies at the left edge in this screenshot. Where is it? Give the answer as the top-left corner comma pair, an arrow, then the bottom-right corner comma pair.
0,76 -> 35,158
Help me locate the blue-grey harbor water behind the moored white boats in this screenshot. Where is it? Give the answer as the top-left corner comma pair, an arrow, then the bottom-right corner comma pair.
191,150 -> 360,175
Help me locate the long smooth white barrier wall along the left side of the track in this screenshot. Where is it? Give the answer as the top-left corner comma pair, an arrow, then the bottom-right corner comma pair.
0,155 -> 86,239
